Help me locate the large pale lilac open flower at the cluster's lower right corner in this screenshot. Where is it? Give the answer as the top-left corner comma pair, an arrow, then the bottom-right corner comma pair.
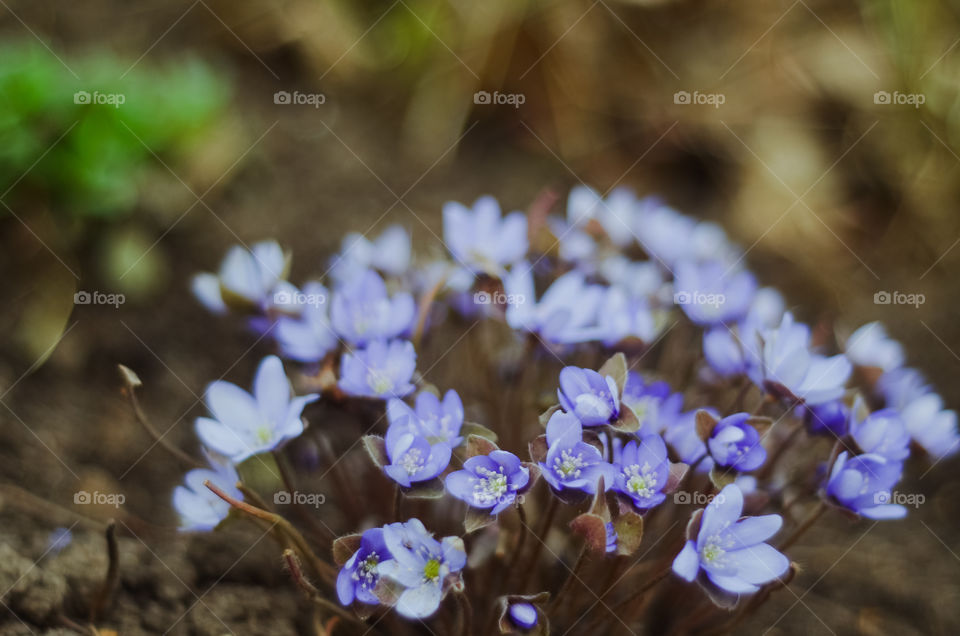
673,484 -> 790,603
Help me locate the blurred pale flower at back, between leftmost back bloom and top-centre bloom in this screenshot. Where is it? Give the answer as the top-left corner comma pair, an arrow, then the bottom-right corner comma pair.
330,225 -> 411,282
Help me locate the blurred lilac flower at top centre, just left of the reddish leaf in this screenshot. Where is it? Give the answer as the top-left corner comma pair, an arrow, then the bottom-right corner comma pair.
443,196 -> 528,275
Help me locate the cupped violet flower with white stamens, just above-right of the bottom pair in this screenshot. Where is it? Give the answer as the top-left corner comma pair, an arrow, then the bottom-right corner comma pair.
446,450 -> 530,515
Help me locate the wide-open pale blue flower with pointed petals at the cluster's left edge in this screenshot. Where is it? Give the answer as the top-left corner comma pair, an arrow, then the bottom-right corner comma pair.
196,356 -> 319,463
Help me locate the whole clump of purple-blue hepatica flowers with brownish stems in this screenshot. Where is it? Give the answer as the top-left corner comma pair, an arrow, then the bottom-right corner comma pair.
173,187 -> 960,634
